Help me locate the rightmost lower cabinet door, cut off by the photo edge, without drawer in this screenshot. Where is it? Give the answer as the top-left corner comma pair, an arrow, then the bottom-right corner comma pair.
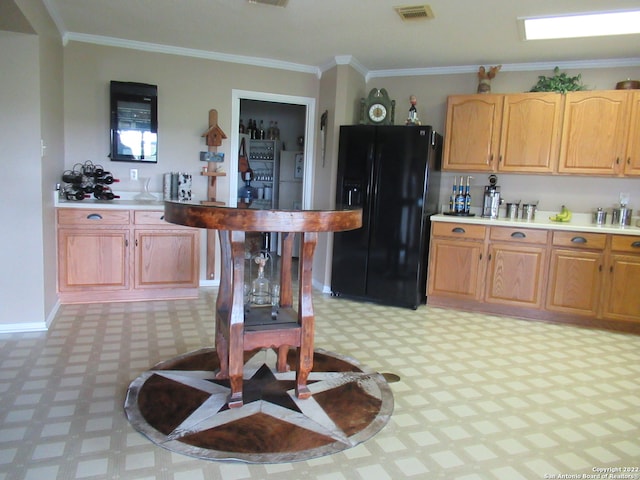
604,254 -> 640,322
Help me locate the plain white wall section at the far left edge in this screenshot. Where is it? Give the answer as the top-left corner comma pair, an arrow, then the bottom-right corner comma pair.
0,31 -> 45,330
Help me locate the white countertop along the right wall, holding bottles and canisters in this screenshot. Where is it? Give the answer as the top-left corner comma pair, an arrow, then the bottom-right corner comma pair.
431,211 -> 640,235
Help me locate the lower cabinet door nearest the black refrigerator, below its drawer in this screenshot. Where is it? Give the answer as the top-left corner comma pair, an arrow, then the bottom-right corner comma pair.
427,238 -> 484,300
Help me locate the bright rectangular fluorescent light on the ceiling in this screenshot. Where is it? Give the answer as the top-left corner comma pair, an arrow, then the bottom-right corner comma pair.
518,10 -> 640,40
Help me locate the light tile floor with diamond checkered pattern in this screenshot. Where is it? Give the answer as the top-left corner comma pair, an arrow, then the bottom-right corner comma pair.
0,289 -> 640,480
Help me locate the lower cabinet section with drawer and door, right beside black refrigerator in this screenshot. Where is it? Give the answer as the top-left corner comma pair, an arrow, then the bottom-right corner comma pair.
427,222 -> 486,300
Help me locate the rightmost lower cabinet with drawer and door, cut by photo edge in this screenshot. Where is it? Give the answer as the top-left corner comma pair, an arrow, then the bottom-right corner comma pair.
603,235 -> 640,322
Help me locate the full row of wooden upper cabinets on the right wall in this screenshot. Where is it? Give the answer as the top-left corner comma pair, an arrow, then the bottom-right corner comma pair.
443,90 -> 640,176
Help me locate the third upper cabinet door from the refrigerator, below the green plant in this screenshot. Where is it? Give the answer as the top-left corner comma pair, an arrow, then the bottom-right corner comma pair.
558,90 -> 629,175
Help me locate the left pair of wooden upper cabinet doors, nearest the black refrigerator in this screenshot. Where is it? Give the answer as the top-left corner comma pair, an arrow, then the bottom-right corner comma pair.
443,93 -> 562,173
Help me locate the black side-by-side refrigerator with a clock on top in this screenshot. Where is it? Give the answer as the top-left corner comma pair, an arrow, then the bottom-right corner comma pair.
331,125 -> 442,309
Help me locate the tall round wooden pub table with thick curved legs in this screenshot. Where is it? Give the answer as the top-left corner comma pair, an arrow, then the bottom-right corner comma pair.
164,201 -> 362,407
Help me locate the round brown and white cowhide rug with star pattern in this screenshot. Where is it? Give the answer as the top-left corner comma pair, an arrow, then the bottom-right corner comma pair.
125,348 -> 393,463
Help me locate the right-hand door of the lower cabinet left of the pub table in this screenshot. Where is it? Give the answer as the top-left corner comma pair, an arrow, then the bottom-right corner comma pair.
134,229 -> 199,288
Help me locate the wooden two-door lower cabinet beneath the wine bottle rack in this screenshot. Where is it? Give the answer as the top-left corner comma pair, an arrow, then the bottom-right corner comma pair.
58,208 -> 200,303
